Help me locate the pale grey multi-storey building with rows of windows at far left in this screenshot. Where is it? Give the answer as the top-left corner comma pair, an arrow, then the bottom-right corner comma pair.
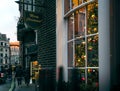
0,33 -> 11,68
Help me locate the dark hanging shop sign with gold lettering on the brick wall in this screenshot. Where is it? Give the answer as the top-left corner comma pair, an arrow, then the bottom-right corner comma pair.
25,11 -> 43,29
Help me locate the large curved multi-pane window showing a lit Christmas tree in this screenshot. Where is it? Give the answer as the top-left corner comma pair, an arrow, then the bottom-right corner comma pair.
65,0 -> 99,91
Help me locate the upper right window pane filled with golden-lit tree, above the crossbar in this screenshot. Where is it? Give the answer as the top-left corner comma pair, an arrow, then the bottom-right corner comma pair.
87,3 -> 98,34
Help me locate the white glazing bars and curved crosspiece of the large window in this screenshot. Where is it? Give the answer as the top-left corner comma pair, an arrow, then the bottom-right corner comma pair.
64,0 -> 99,84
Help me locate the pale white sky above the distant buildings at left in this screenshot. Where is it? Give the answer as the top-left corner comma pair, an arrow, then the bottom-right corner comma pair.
0,0 -> 20,42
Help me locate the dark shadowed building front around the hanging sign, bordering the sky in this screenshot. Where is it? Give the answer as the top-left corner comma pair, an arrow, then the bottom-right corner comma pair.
17,0 -> 37,68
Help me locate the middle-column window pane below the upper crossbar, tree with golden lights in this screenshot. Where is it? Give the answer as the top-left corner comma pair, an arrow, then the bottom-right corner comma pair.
75,38 -> 86,67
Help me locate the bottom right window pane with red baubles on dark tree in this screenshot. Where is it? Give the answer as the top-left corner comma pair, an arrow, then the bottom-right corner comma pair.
87,69 -> 99,91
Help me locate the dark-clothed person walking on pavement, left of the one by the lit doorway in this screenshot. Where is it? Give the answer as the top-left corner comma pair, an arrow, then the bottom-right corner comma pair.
15,66 -> 23,86
